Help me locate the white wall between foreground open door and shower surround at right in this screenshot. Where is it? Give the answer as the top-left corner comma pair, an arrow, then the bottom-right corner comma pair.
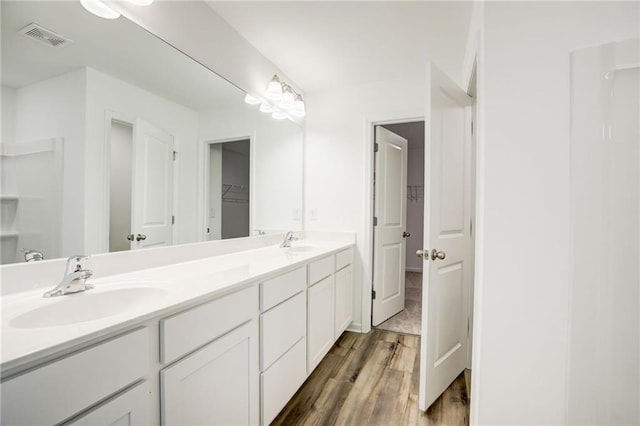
471,2 -> 639,425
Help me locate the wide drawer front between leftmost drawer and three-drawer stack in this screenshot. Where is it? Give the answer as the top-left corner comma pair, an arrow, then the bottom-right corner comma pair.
160,286 -> 258,364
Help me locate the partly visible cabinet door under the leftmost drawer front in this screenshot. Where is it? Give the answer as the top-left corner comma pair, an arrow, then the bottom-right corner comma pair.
71,382 -> 149,426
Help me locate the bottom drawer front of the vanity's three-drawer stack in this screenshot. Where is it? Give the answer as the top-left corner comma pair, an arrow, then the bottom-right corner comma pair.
260,338 -> 307,425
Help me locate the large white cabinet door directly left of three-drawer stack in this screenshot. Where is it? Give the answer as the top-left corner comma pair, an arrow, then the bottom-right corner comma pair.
160,321 -> 259,425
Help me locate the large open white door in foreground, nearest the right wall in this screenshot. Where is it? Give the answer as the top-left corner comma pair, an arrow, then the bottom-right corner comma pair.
418,64 -> 472,410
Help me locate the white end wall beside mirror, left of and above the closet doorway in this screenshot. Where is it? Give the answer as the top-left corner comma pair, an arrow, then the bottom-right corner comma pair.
304,69 -> 425,331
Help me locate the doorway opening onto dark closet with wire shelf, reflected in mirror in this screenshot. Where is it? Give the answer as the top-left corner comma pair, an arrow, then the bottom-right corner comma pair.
207,139 -> 251,240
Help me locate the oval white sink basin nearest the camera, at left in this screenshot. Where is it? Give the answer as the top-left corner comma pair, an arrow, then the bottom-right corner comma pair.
9,287 -> 167,328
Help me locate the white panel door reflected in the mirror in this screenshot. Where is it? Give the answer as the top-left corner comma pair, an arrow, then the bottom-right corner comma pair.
131,119 -> 174,249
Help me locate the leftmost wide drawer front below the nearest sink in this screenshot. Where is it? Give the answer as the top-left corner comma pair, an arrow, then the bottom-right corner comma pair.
0,328 -> 149,425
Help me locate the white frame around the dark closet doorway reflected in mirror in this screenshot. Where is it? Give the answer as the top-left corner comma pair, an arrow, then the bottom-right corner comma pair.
197,135 -> 255,242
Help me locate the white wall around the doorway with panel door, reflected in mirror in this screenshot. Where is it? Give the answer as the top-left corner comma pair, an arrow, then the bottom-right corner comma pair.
84,68 -> 201,253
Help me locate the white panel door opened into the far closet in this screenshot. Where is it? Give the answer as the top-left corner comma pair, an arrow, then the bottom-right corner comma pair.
371,126 -> 408,326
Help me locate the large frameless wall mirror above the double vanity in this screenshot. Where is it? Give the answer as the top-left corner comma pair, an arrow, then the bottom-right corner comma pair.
0,0 -> 303,264
